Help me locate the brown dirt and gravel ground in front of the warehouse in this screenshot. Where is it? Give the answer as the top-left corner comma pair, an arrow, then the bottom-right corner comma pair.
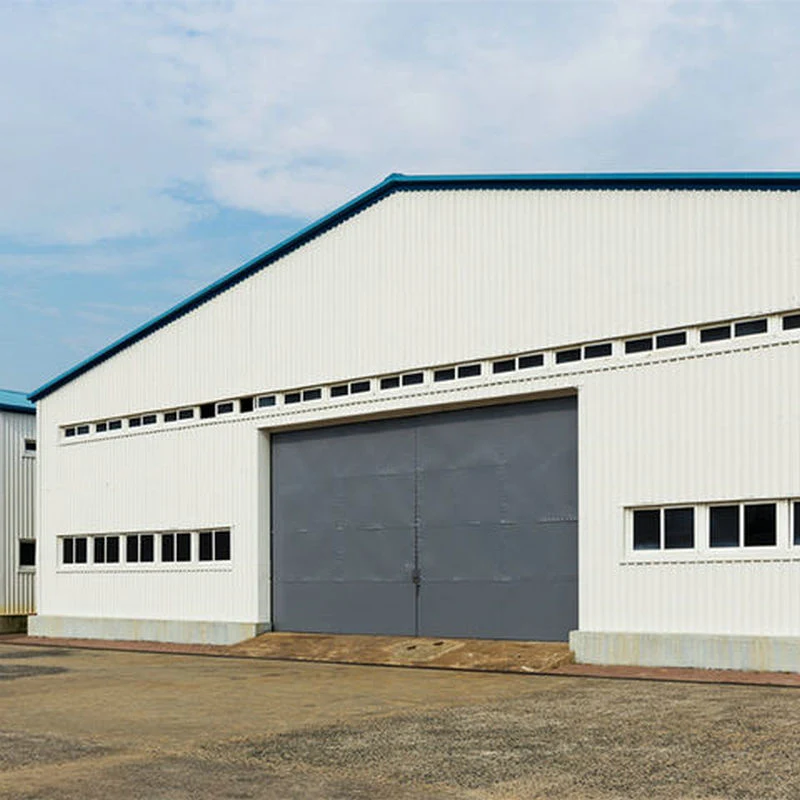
0,644 -> 800,800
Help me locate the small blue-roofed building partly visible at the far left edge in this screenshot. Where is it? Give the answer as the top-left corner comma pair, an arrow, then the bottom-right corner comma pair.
0,389 -> 36,633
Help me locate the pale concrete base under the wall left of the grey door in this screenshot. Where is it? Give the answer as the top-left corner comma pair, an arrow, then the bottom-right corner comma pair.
28,614 -> 270,645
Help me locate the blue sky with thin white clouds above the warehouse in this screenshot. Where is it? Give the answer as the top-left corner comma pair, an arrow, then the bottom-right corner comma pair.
0,0 -> 800,391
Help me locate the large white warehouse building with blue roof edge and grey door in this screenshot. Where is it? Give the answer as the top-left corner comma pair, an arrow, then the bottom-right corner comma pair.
29,173 -> 800,670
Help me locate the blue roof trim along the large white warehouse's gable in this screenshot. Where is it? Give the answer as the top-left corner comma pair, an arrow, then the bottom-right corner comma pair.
28,172 -> 800,402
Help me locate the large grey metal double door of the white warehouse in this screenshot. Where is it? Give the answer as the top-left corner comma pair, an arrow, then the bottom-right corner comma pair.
272,397 -> 578,640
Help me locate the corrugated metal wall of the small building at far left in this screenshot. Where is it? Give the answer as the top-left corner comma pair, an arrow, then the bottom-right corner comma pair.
0,411 -> 36,615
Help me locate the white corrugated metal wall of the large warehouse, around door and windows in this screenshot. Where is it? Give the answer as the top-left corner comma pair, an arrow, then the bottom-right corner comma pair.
40,186 -> 800,635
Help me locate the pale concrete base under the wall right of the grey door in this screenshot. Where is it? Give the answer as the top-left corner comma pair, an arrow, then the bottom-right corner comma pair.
569,631 -> 800,672
